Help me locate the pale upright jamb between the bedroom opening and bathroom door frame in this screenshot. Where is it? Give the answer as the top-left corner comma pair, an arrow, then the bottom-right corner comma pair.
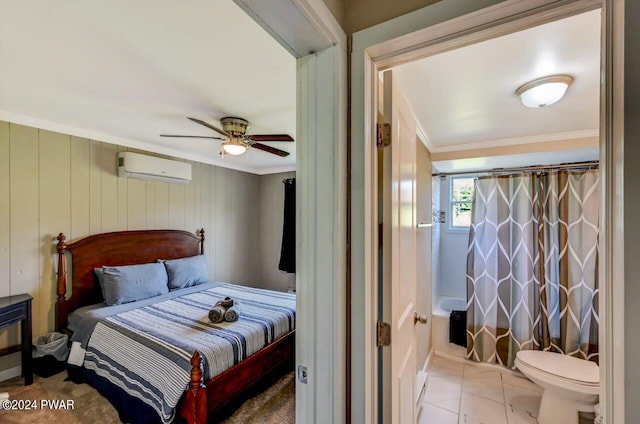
296,46 -> 348,423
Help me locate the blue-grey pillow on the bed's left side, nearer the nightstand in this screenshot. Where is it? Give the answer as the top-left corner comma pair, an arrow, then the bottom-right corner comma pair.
96,262 -> 169,306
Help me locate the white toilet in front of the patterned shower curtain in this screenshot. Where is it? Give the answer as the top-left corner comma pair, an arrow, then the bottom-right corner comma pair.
515,350 -> 600,424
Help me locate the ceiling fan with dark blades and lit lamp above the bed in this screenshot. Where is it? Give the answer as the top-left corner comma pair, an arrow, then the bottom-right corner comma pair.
160,116 -> 293,157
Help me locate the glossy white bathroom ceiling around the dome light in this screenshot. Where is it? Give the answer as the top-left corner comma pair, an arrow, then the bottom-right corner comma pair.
393,10 -> 600,158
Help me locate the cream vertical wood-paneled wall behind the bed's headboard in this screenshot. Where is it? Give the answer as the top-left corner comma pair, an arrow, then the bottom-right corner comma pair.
0,121 -> 262,370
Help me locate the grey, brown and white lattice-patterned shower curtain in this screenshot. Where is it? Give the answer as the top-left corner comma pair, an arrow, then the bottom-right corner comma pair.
467,170 -> 600,368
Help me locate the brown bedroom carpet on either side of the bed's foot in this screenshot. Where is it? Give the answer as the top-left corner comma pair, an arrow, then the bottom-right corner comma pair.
0,372 -> 295,424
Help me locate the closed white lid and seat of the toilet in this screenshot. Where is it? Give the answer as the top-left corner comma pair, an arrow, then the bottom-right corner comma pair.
516,350 -> 600,388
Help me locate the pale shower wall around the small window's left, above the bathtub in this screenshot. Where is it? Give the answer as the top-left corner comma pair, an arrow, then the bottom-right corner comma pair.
435,177 -> 469,299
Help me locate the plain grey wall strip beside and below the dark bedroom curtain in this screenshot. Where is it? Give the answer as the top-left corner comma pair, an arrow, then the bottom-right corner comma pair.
258,172 -> 296,291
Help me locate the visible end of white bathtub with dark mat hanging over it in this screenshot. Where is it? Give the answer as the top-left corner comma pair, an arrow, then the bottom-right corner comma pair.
431,296 -> 467,358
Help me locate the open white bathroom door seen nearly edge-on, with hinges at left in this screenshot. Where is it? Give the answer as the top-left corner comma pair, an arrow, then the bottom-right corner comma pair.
382,71 -> 416,424
